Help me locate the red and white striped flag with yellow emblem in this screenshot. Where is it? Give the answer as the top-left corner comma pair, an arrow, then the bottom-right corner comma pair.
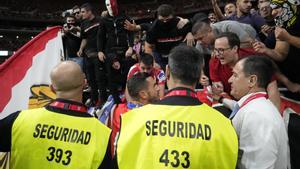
0,26 -> 63,119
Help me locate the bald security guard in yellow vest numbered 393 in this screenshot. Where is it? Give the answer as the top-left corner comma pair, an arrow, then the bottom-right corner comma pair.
0,61 -> 110,169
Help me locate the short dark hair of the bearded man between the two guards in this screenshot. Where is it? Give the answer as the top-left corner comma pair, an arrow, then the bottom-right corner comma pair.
127,72 -> 151,100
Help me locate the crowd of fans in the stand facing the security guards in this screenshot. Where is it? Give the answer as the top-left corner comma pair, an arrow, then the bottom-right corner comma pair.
59,0 -> 300,168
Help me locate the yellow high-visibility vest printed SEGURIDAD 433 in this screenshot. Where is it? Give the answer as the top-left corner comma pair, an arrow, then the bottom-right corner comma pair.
117,104 -> 238,169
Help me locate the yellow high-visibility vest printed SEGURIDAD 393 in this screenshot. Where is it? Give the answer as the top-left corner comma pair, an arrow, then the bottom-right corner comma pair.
10,108 -> 110,169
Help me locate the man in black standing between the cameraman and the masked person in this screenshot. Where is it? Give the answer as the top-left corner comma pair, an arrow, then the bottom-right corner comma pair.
77,3 -> 107,106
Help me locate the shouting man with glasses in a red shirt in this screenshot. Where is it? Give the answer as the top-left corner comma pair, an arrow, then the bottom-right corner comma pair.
209,32 -> 280,112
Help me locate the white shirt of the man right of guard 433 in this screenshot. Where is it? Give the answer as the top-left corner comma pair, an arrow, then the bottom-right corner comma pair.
232,92 -> 290,169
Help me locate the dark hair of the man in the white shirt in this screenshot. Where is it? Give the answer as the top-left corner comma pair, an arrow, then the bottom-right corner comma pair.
242,55 -> 274,89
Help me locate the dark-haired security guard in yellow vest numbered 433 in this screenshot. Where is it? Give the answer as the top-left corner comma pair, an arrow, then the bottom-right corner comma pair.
115,46 -> 238,169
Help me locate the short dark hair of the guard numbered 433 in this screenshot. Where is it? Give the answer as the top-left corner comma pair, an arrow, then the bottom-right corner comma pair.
168,45 -> 204,85
